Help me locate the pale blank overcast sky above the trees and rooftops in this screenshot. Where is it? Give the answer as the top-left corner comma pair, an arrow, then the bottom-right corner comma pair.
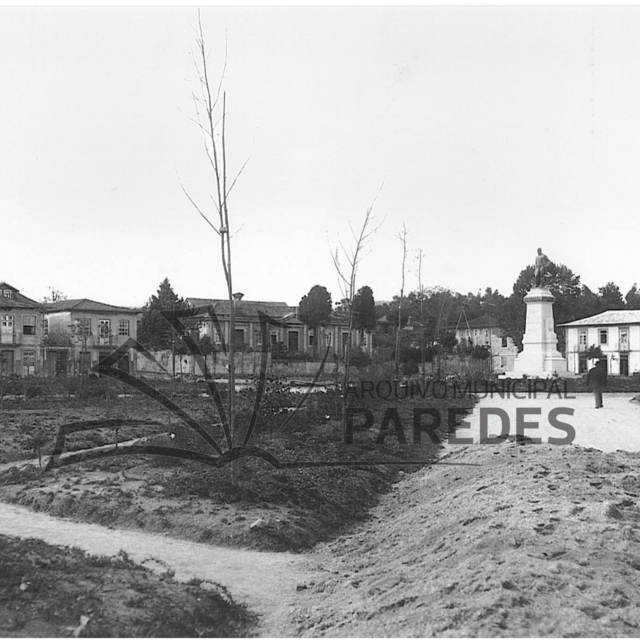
0,3 -> 640,305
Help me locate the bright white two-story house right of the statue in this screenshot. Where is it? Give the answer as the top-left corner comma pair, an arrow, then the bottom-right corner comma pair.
559,309 -> 640,376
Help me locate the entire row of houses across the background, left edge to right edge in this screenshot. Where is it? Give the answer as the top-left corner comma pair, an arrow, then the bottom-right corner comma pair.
0,282 -> 640,376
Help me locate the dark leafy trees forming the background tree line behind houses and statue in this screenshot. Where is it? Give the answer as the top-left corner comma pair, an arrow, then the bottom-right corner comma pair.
138,263 -> 640,362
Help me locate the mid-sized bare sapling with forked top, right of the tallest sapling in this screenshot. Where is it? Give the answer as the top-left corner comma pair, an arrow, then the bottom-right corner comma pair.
331,199 -> 384,442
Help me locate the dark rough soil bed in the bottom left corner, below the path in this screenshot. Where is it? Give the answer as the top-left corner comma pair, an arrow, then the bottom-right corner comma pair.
0,536 -> 256,638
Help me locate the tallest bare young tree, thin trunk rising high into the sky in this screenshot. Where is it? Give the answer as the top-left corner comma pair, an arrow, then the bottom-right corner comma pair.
180,12 -> 247,483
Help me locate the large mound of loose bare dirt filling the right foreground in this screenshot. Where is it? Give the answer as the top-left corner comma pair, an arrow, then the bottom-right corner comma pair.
291,442 -> 640,638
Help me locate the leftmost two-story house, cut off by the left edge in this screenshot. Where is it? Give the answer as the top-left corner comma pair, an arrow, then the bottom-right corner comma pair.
0,282 -> 42,376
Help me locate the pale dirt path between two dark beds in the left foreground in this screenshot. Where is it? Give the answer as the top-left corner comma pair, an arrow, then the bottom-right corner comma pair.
0,503 -> 325,638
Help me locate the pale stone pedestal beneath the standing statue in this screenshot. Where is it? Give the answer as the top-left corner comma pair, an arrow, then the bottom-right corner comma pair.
513,287 -> 567,378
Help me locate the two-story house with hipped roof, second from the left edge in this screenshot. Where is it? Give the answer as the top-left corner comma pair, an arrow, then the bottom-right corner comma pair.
44,298 -> 140,375
